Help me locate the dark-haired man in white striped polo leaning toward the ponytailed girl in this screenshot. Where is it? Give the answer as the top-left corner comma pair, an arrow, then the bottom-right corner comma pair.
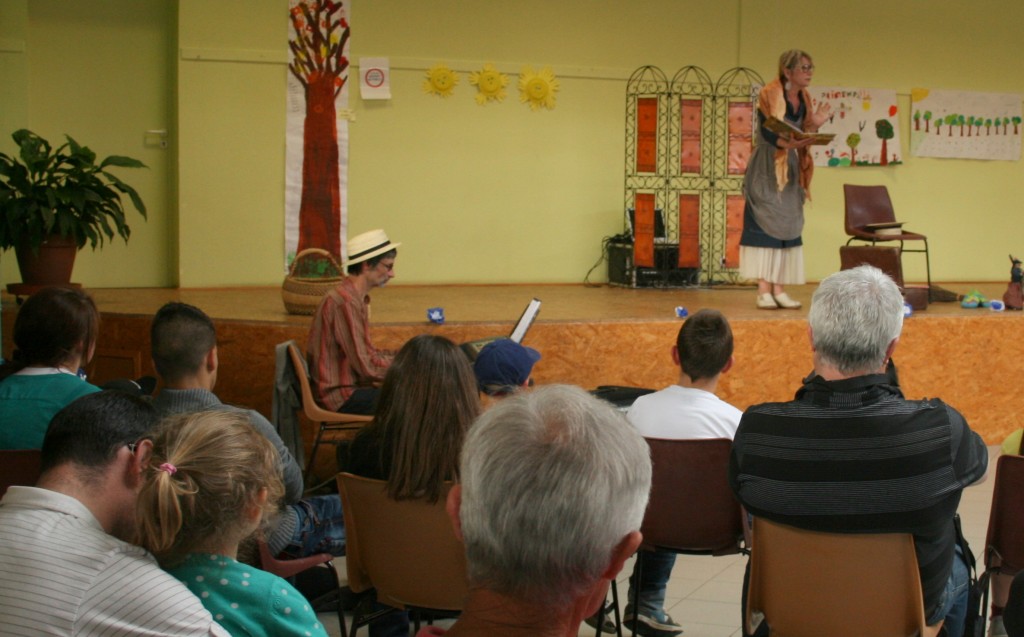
0,391 -> 227,637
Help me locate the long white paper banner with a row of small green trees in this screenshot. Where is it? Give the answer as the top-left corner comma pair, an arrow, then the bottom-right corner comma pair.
910,88 -> 1021,161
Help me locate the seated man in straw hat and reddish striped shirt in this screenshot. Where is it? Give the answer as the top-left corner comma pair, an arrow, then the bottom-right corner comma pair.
306,229 -> 401,414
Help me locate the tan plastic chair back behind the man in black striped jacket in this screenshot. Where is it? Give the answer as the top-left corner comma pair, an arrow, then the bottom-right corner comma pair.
743,518 -> 937,637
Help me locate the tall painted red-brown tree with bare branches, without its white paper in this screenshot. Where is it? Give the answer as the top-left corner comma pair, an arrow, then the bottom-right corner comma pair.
288,0 -> 349,258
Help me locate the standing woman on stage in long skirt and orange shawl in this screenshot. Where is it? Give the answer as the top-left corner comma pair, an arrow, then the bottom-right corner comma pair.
739,49 -> 830,309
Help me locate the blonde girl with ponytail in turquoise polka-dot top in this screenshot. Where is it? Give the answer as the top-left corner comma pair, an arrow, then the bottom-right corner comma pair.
136,411 -> 327,637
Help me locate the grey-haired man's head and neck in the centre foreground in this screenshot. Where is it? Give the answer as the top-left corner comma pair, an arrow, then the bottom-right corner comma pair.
421,385 -> 650,637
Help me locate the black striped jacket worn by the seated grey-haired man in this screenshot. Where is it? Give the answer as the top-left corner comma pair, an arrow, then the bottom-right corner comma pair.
729,374 -> 988,617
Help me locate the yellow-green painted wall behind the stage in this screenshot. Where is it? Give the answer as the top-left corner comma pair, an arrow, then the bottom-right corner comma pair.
0,0 -> 1024,287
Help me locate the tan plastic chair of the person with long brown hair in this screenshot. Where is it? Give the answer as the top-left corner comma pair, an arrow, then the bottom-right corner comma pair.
338,473 -> 469,636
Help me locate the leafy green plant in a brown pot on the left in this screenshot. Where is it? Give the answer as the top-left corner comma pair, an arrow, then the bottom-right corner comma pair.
0,128 -> 145,286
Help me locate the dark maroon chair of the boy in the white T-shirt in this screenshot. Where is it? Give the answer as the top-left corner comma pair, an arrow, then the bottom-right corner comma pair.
598,438 -> 743,634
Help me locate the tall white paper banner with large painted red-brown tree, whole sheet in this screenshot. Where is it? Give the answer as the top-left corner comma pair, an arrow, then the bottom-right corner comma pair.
285,0 -> 352,266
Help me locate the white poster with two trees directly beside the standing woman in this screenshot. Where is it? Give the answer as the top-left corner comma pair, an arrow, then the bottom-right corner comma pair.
807,86 -> 903,167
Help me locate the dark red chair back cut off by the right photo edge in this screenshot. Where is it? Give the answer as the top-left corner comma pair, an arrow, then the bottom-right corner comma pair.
985,456 -> 1024,576
